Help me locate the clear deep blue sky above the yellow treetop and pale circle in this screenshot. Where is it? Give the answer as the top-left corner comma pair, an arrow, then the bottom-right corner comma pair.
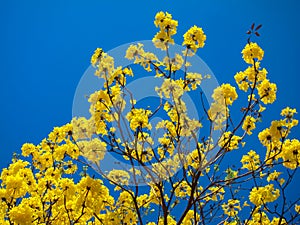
0,0 -> 300,220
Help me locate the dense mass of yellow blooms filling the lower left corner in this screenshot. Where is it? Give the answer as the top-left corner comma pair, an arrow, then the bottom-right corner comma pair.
0,127 -> 118,224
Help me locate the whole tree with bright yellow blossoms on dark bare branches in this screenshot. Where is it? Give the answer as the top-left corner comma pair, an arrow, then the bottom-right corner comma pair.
0,12 -> 300,225
